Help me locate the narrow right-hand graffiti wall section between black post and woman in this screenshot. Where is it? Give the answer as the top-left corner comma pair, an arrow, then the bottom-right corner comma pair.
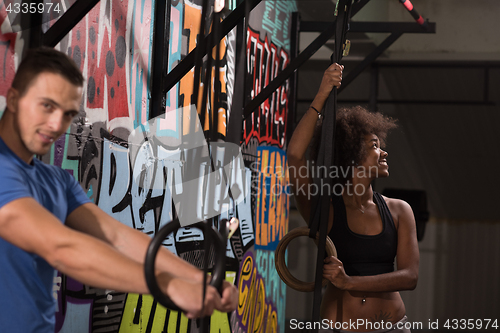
236,1 -> 296,332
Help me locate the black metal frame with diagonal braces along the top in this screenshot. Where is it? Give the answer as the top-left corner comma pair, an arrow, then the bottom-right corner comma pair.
25,0 -> 436,126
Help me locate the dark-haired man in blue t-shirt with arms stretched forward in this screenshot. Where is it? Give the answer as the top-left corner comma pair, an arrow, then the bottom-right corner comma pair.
0,48 -> 238,333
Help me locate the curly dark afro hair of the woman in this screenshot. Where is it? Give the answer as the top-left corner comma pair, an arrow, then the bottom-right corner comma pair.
310,105 -> 397,184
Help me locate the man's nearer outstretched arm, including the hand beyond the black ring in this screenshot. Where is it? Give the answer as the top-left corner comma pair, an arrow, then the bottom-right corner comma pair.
0,198 -> 229,318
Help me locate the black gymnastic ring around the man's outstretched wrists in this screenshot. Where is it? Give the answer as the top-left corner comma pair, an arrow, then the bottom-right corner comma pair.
144,219 -> 226,311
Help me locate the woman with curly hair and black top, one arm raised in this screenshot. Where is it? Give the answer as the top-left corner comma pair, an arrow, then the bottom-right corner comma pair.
287,64 -> 419,332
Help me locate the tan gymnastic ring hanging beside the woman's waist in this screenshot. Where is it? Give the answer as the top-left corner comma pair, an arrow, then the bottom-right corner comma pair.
274,227 -> 337,292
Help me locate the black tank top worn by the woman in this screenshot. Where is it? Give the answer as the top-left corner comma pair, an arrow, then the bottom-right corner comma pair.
328,192 -> 398,276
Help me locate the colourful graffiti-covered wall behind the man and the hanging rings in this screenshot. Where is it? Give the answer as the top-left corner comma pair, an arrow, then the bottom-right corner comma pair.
0,0 -> 296,333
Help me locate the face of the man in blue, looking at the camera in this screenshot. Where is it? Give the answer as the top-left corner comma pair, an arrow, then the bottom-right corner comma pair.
8,72 -> 83,160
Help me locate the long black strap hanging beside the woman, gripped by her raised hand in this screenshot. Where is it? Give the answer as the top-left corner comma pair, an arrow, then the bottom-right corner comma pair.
309,0 -> 352,326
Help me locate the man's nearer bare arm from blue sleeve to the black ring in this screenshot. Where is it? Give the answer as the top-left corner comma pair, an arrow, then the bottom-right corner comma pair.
0,198 -> 148,293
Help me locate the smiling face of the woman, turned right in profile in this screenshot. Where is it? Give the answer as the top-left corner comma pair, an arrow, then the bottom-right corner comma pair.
358,134 -> 389,179
